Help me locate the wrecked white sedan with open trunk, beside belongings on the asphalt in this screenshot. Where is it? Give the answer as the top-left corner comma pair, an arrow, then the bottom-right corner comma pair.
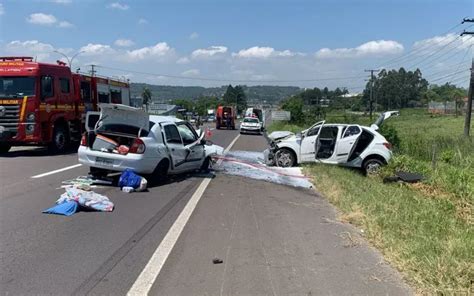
78,104 -> 223,177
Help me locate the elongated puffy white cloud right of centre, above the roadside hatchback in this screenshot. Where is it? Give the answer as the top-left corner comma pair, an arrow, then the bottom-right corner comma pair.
315,40 -> 404,59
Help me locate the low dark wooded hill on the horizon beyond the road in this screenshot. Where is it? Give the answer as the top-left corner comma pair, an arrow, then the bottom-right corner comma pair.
131,83 -> 302,104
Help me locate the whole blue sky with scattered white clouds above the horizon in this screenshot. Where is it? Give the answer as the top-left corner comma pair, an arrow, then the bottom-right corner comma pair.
0,0 -> 474,91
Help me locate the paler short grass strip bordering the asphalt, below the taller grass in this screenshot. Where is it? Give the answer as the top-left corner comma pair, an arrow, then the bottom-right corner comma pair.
304,164 -> 474,295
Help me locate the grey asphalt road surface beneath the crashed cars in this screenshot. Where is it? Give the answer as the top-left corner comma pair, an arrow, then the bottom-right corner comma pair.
0,123 -> 410,295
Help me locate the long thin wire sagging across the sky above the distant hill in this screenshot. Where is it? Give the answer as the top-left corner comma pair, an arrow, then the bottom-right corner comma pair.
96,66 -> 364,83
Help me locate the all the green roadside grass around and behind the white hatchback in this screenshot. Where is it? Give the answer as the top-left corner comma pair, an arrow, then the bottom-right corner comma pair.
269,109 -> 474,295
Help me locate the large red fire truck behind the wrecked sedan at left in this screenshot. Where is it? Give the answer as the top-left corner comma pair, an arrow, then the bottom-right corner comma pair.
0,57 -> 130,153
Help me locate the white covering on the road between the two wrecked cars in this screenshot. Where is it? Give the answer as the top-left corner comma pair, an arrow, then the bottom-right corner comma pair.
217,151 -> 314,188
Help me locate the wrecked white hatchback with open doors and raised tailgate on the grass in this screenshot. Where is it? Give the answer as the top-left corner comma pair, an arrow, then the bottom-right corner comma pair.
264,111 -> 399,173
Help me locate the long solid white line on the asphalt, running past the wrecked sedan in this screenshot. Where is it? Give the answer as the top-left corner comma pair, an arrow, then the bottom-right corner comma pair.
127,134 -> 240,296
